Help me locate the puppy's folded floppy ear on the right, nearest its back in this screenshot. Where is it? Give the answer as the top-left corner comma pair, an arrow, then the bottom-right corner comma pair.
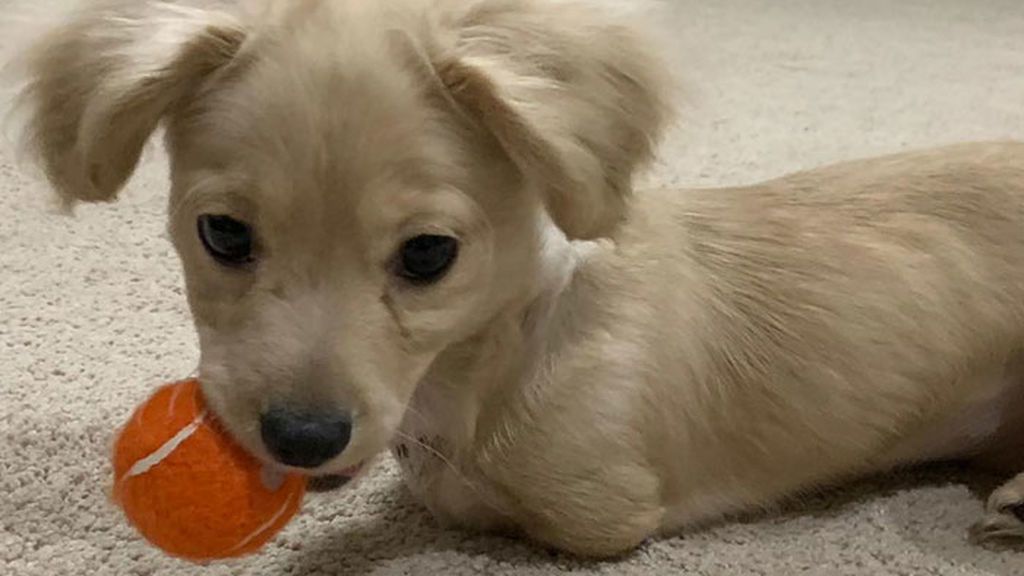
435,0 -> 669,239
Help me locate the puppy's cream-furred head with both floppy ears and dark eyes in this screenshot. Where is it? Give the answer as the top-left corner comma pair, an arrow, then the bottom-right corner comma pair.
24,0 -> 665,472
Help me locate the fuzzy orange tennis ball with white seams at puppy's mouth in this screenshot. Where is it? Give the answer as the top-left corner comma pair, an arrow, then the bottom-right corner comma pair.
114,380 -> 306,562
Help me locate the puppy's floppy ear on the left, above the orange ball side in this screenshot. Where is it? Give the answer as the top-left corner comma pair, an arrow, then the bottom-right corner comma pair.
14,0 -> 245,207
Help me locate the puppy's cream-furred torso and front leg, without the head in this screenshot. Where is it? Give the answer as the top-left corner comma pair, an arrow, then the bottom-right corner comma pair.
397,143 -> 1024,553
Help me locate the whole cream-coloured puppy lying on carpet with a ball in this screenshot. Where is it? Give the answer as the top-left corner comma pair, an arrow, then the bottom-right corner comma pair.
14,0 -> 1024,556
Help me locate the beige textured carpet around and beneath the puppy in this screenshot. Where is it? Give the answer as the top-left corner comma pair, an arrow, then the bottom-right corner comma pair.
0,0 -> 1024,576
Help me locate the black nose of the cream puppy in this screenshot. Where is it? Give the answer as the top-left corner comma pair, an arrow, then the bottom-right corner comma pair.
260,408 -> 352,468
